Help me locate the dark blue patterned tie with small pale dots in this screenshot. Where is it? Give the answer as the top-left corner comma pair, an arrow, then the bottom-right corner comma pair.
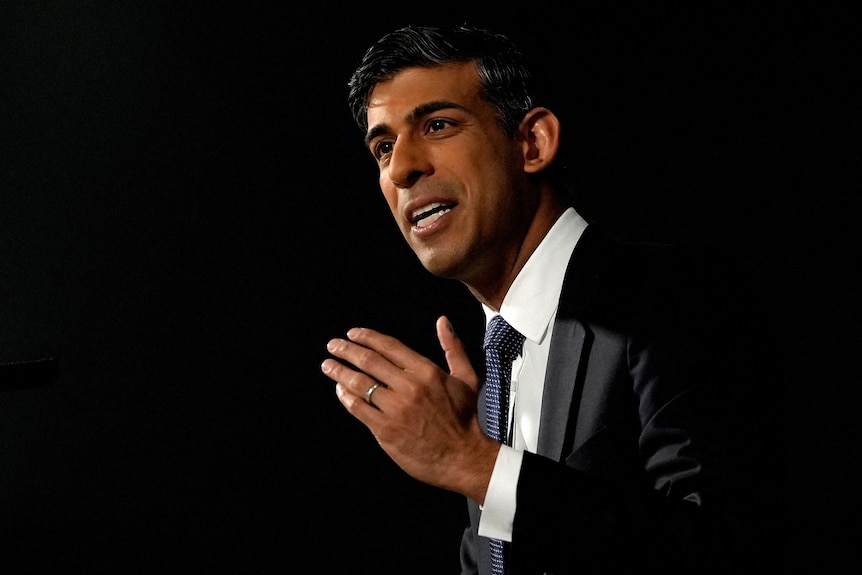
483,315 -> 524,575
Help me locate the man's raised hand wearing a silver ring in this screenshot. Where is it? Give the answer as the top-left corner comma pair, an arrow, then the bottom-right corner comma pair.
321,316 -> 500,503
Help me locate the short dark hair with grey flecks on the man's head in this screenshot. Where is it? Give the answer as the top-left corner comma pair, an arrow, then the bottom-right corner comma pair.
347,26 -> 533,137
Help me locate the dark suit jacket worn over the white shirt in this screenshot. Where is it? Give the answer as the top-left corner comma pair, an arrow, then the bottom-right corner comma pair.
461,225 -> 781,575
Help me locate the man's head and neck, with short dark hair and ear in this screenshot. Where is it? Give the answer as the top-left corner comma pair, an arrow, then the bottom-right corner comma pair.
350,24 -> 564,306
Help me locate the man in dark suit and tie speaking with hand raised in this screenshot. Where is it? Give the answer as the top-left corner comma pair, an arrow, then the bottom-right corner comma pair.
321,27 -> 770,575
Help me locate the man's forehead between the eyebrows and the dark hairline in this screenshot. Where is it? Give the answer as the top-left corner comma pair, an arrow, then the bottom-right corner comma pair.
368,62 -> 483,126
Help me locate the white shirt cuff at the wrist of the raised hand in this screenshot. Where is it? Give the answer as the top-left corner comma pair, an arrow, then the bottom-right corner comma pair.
478,445 -> 524,541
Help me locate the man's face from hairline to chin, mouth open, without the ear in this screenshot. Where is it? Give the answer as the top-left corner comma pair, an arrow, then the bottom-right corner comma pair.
367,63 -> 531,285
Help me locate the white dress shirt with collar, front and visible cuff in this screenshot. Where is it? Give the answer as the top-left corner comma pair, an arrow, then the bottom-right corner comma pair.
478,208 -> 587,541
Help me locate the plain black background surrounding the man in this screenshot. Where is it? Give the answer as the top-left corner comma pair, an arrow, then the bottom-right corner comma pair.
0,1 -> 859,573
